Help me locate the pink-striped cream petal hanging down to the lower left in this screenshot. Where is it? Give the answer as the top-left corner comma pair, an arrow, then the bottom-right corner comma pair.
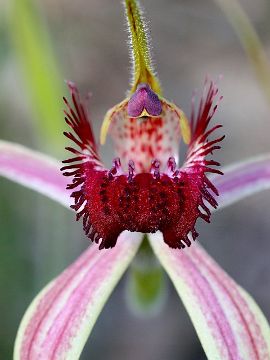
14,232 -> 142,360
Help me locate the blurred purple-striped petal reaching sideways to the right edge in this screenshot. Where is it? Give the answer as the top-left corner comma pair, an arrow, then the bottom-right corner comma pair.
211,154 -> 270,209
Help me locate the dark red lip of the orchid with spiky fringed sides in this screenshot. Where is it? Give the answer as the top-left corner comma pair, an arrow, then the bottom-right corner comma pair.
61,83 -> 223,249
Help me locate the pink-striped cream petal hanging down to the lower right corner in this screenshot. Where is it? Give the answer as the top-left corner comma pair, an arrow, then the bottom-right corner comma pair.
150,233 -> 270,360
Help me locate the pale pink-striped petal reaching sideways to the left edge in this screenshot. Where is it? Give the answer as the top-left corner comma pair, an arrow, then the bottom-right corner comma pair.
0,141 -> 71,207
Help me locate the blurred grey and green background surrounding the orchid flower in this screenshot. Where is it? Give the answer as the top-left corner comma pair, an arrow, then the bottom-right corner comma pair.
0,0 -> 270,360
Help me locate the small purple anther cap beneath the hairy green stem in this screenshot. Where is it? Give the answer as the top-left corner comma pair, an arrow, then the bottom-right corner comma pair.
128,83 -> 162,117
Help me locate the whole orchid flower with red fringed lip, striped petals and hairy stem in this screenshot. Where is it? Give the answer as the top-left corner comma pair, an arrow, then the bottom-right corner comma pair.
0,0 -> 270,360
